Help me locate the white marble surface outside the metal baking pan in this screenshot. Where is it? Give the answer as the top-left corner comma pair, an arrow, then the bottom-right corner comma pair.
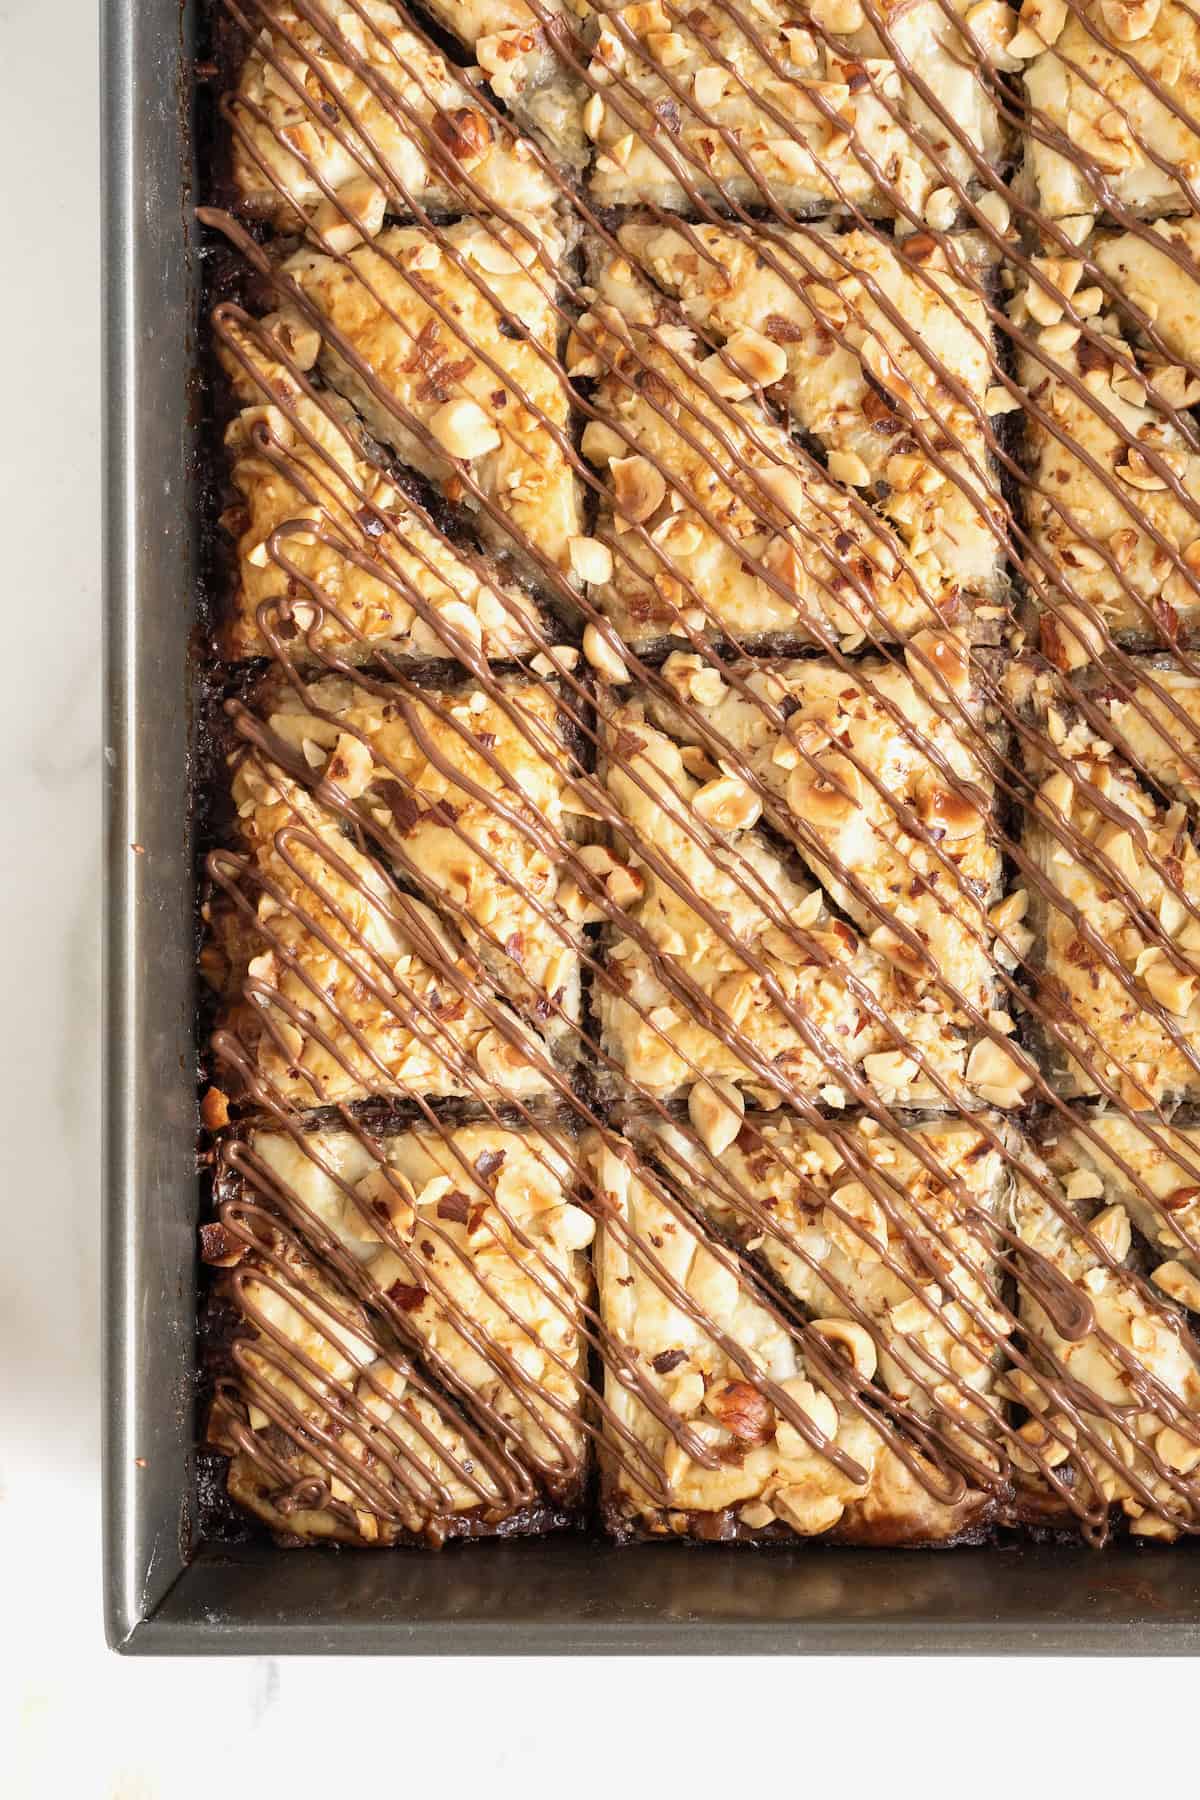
0,0 -> 1196,1800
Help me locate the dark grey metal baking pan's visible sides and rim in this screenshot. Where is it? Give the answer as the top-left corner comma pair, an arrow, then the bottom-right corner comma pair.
103,0 -> 1200,1654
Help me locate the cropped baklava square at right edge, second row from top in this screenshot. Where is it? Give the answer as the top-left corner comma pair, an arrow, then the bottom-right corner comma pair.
1011,234 -> 1200,651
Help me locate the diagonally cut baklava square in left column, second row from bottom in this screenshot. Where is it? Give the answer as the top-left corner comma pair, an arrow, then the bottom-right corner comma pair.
205,680 -> 578,1107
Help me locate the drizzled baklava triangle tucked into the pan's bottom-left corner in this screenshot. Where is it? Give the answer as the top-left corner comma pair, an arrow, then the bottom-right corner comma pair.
201,1206 -> 561,1548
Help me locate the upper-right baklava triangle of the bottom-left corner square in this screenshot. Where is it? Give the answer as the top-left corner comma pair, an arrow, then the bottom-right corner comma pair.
230,1123 -> 594,1505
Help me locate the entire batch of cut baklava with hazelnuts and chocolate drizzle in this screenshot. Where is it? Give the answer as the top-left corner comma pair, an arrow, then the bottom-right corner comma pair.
198,0 -> 1200,1553
